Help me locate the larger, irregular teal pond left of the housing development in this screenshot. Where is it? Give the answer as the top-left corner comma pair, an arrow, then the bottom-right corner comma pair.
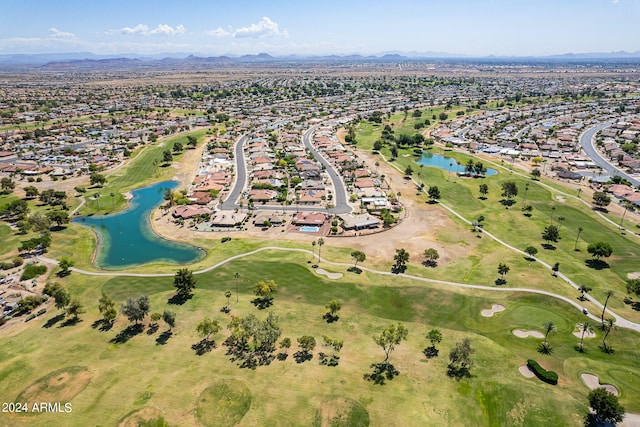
74,181 -> 205,269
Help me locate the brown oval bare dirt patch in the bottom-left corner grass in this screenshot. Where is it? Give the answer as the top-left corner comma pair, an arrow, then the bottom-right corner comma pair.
16,366 -> 91,402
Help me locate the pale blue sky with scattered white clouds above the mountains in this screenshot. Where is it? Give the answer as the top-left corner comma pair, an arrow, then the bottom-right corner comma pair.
0,0 -> 640,56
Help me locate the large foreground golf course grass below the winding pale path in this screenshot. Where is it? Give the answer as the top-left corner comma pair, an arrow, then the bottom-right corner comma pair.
0,251 -> 640,426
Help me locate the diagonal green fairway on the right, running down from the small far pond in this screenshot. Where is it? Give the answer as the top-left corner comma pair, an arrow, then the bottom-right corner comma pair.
356,115 -> 640,322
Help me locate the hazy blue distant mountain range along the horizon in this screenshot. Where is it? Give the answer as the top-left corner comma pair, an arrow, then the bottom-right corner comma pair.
0,51 -> 640,69
